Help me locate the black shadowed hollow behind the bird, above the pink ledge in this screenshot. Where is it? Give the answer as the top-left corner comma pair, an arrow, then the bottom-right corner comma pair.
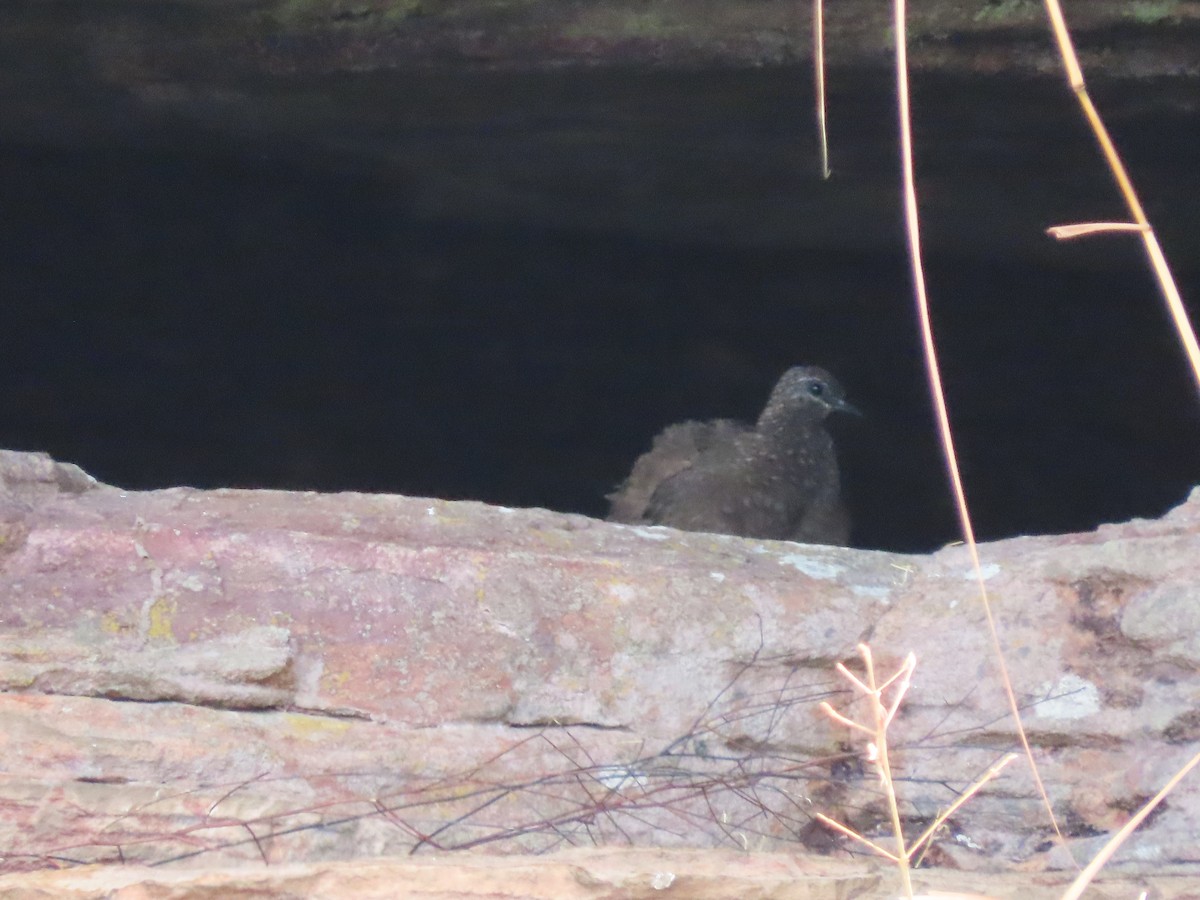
0,61 -> 1200,550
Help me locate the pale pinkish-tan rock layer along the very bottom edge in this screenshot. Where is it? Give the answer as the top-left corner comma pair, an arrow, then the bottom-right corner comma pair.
7,850 -> 1196,900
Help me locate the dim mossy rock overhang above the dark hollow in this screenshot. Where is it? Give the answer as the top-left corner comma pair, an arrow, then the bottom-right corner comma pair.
9,0 -> 1198,80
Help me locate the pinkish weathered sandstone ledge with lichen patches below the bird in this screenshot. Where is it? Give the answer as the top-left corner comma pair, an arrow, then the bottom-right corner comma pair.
0,451 -> 1200,896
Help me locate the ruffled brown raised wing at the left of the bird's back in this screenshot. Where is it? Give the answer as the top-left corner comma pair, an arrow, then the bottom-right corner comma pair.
608,419 -> 746,522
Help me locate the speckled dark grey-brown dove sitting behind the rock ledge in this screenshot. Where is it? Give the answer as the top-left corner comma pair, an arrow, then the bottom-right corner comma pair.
608,366 -> 858,545
